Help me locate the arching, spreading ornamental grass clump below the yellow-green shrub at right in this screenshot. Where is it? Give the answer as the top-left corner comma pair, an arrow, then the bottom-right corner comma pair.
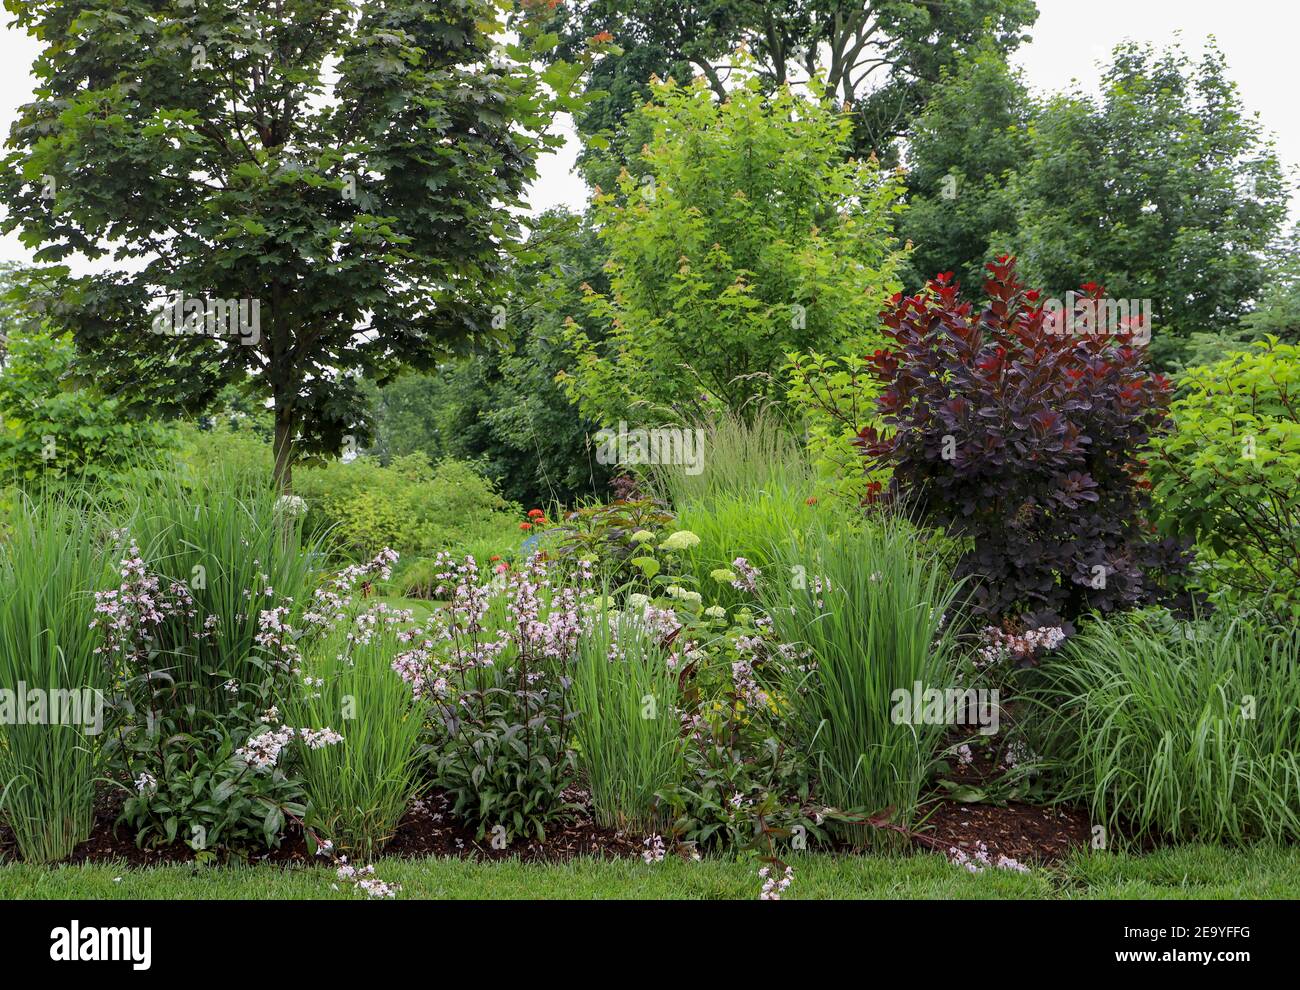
1028,611 -> 1300,843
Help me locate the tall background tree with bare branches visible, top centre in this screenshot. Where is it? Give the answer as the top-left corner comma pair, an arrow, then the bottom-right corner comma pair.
519,0 -> 1039,166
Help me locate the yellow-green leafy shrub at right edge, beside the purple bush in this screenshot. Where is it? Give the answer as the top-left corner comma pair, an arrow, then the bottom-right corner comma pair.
1151,339 -> 1300,616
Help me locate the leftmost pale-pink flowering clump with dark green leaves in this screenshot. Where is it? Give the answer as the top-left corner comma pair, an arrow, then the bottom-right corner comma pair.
92,534 -> 395,856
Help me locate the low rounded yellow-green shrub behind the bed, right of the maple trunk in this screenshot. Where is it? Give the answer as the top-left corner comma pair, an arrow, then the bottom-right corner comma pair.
298,453 -> 521,559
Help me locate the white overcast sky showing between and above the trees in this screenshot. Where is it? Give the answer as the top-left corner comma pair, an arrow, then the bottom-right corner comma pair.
0,0 -> 1300,268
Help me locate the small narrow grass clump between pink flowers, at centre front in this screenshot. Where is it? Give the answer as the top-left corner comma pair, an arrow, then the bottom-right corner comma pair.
573,613 -> 685,834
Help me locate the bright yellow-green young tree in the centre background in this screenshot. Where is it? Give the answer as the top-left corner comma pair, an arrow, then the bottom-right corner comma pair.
563,68 -> 901,424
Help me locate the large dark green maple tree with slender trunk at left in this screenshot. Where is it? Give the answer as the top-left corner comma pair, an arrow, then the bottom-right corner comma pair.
0,0 -> 595,483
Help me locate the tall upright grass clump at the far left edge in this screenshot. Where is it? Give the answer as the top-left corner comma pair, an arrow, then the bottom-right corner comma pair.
0,496 -> 111,863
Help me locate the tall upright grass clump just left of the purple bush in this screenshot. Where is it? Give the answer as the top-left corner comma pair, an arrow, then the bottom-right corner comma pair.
758,516 -> 958,843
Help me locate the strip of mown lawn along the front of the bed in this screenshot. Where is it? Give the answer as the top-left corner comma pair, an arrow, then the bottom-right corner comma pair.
0,846 -> 1300,900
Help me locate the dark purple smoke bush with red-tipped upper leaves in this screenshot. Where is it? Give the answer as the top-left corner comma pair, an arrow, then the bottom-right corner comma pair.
861,257 -> 1186,625
